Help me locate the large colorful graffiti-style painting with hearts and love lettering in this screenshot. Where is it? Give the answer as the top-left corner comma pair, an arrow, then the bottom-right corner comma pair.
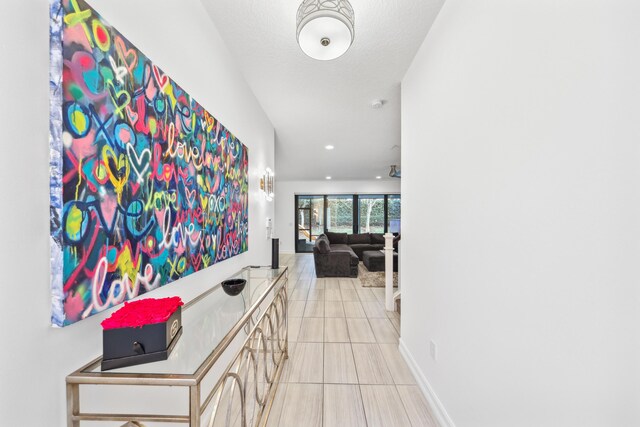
49,0 -> 249,326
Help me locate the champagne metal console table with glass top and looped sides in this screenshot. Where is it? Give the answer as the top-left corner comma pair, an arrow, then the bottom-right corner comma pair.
66,267 -> 288,427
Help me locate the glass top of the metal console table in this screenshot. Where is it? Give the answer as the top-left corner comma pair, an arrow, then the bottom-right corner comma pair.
86,267 -> 286,375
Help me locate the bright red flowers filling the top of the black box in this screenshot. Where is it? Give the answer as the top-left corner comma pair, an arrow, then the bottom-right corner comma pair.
101,297 -> 184,330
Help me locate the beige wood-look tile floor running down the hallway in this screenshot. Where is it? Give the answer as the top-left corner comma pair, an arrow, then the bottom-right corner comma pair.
268,254 -> 436,427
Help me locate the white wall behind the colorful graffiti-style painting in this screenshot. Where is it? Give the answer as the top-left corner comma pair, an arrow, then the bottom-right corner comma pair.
0,0 -> 274,427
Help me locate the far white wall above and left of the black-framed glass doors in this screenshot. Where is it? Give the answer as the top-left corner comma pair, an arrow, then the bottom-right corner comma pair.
273,179 -> 400,253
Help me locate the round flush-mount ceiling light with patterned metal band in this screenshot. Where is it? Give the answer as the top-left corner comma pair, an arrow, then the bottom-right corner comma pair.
296,0 -> 355,61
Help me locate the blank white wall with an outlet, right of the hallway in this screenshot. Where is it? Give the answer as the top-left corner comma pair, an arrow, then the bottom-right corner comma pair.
402,0 -> 640,427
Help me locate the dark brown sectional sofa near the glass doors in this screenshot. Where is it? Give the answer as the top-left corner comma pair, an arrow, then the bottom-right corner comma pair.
313,231 -> 384,277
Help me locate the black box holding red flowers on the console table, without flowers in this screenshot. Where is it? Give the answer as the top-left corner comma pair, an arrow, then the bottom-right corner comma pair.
101,307 -> 182,371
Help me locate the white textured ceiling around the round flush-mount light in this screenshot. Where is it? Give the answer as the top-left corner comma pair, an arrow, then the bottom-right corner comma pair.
202,0 -> 444,180
